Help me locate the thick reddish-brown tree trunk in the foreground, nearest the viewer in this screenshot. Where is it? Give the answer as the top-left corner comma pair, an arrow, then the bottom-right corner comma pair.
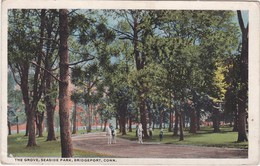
59,9 -> 73,157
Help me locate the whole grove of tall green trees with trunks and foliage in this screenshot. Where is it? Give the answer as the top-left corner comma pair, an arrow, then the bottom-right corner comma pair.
8,9 -> 248,157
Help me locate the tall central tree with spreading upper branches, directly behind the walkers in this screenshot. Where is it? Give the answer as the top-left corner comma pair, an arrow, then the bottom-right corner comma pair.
111,10 -> 158,138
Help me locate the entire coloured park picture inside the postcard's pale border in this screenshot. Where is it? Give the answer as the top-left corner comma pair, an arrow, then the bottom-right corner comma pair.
7,9 -> 251,159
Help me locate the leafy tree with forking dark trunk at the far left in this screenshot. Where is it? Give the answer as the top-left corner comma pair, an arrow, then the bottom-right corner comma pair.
8,10 -> 45,147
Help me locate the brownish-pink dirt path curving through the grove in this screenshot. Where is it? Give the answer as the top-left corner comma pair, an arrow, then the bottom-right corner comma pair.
72,132 -> 248,158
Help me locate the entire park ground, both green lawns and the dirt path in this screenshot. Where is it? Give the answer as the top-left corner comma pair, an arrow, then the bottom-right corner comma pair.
8,127 -> 248,158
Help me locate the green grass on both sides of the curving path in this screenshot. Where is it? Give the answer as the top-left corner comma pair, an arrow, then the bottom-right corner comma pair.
8,127 -> 248,157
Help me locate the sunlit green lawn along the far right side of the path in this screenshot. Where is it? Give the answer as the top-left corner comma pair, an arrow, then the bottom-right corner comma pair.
118,127 -> 248,149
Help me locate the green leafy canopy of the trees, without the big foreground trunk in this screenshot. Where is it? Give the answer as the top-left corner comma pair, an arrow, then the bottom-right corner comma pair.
8,10 -> 244,143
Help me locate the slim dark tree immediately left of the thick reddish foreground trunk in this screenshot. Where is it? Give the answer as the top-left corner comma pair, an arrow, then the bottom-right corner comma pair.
44,9 -> 59,141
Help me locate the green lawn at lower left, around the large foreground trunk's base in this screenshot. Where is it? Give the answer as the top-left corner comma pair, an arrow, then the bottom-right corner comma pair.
8,133 -> 107,157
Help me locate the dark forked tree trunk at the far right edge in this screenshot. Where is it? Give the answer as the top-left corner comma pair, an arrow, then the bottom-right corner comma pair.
237,10 -> 249,142
